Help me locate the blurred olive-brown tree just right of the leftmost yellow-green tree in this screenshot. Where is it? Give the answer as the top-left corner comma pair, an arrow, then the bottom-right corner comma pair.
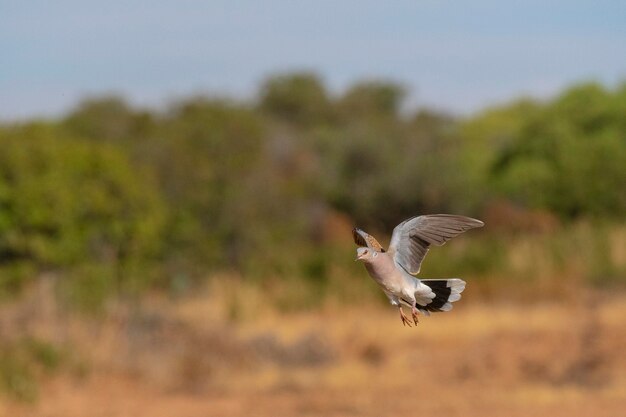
154,98 -> 263,267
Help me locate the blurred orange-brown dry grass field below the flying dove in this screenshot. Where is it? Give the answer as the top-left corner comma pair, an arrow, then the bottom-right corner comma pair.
0,282 -> 626,417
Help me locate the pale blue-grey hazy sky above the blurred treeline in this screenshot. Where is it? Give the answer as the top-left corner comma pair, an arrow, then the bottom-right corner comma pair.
0,0 -> 626,120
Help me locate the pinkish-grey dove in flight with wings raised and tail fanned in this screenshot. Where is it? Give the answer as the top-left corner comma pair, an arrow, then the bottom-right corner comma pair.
352,214 -> 485,327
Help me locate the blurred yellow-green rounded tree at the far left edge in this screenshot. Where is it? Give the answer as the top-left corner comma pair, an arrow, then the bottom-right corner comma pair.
0,124 -> 166,298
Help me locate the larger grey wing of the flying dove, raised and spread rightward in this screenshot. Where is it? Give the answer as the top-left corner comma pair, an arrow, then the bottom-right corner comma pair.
389,214 -> 484,275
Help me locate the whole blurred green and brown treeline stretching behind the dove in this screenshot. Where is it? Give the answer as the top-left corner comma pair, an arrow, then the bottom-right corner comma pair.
0,73 -> 626,305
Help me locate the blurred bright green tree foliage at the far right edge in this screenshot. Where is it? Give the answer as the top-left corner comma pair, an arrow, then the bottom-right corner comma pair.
466,84 -> 626,219
